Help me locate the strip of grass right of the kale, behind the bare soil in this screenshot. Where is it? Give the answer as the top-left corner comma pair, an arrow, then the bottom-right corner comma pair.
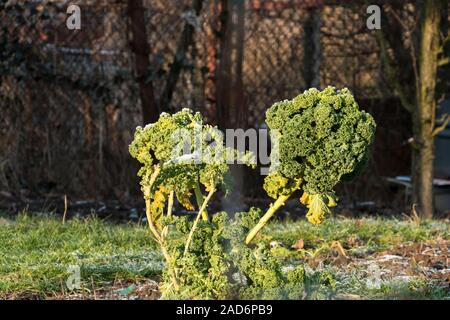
264,217 -> 450,256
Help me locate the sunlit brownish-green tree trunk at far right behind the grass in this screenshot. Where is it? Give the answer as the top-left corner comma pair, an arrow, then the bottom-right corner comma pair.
412,0 -> 443,218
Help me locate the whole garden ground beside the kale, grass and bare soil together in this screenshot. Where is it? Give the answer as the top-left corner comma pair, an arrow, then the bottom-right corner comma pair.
0,213 -> 450,299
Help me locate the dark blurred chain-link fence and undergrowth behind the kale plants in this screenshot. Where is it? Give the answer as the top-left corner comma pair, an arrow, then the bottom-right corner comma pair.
0,0 -> 450,216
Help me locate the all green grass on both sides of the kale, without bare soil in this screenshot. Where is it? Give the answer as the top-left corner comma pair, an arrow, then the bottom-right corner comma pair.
0,214 -> 450,299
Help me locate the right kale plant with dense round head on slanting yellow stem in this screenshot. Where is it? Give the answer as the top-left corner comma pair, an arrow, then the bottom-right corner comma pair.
246,87 -> 376,243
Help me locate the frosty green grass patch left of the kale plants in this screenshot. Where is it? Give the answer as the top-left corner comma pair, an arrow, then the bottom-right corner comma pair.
0,214 -> 163,297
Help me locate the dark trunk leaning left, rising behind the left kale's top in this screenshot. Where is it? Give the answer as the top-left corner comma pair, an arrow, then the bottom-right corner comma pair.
128,0 -> 159,124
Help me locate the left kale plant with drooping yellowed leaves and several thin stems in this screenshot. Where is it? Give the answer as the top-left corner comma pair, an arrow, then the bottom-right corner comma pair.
129,109 -> 255,297
